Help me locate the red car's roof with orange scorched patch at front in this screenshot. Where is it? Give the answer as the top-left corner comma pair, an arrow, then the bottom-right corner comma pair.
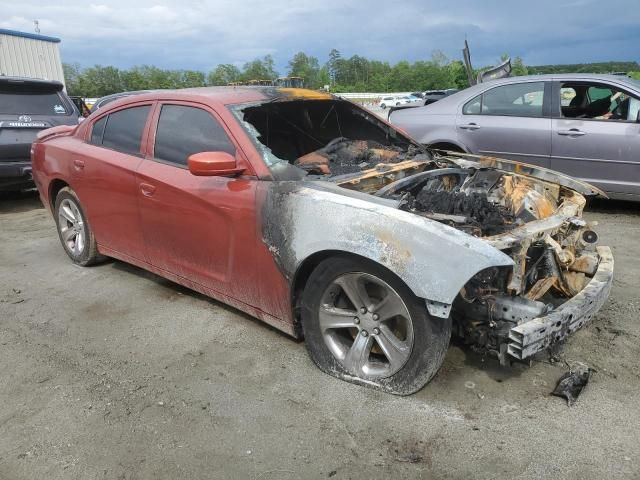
100,86 -> 336,108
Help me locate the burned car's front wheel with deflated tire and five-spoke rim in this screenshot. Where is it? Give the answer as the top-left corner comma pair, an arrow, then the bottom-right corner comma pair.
301,256 -> 451,395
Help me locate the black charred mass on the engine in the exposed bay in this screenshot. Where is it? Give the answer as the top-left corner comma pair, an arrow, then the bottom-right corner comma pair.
409,187 -> 514,235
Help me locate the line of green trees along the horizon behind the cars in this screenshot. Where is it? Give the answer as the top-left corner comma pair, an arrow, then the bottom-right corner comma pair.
63,49 -> 640,97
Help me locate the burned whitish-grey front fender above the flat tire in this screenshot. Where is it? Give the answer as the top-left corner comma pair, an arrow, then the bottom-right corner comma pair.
262,181 -> 513,314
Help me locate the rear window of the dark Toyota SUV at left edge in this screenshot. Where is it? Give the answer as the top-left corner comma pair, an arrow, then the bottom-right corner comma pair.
0,88 -> 72,116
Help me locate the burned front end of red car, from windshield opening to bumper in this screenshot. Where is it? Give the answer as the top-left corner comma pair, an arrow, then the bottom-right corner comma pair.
232,90 -> 613,364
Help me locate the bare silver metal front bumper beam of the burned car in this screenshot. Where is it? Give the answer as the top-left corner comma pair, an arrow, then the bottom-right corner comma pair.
507,247 -> 613,360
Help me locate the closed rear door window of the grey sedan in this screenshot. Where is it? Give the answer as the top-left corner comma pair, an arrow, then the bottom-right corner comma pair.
462,82 -> 544,117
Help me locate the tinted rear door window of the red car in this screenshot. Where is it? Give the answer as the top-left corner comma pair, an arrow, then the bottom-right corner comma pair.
100,105 -> 151,154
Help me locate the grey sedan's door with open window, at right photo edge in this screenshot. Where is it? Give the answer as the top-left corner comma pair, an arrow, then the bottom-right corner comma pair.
551,81 -> 640,197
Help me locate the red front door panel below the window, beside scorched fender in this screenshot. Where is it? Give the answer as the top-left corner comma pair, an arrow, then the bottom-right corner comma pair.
138,160 -> 258,301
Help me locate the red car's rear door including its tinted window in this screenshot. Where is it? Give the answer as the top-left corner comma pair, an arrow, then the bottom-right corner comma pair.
73,102 -> 153,261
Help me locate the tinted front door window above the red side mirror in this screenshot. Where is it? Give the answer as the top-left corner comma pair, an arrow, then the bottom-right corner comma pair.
153,105 -> 236,165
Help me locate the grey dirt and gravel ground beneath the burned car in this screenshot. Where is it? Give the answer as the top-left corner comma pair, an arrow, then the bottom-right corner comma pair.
0,189 -> 640,480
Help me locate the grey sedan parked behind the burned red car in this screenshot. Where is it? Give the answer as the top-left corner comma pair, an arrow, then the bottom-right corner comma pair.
389,74 -> 640,200
